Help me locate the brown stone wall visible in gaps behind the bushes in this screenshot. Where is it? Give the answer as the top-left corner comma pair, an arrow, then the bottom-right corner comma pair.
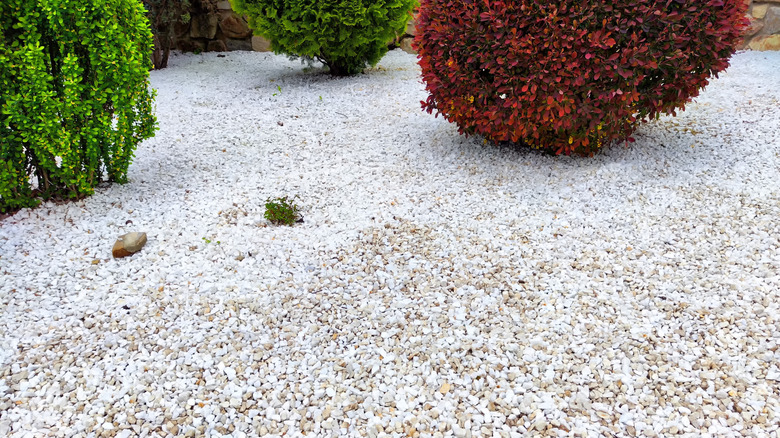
176,0 -> 780,53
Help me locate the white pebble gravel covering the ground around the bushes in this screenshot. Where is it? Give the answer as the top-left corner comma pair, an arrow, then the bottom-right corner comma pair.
0,51 -> 780,438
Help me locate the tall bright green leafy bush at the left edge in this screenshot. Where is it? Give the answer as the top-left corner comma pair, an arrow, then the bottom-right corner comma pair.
0,0 -> 156,211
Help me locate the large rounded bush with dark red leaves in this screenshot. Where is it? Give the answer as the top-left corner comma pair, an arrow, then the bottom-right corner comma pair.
415,0 -> 747,155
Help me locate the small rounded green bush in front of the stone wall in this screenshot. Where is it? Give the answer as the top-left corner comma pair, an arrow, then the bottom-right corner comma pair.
230,0 -> 417,76
